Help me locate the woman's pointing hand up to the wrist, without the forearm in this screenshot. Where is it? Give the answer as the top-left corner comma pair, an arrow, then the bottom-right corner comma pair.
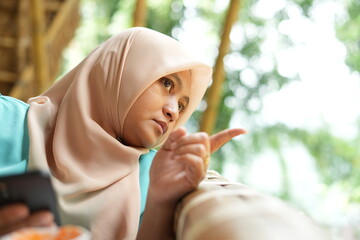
149,128 -> 245,205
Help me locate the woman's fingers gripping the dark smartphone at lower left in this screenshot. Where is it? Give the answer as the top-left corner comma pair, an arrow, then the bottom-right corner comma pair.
0,204 -> 55,236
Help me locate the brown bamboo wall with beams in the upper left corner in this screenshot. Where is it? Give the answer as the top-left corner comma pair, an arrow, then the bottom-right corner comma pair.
0,0 -> 80,101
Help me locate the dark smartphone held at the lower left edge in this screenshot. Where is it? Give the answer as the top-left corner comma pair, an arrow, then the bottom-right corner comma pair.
0,171 -> 61,226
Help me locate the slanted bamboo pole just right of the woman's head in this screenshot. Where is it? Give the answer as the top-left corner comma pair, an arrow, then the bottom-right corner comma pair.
200,0 -> 240,134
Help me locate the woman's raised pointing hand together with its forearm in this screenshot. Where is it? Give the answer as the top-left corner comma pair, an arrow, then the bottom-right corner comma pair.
137,128 -> 245,240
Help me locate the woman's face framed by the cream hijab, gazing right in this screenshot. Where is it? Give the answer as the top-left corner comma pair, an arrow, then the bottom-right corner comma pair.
121,71 -> 191,148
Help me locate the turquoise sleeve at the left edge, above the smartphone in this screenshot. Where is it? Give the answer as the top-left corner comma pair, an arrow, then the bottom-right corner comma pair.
0,94 -> 29,176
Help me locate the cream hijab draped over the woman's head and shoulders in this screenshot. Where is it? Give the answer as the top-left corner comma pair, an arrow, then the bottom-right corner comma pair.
28,28 -> 212,240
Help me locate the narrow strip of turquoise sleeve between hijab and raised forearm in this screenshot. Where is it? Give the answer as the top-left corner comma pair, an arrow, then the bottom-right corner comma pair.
139,149 -> 156,222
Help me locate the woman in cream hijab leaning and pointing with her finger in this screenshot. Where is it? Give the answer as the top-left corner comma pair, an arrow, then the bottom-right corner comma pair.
0,28 -> 243,240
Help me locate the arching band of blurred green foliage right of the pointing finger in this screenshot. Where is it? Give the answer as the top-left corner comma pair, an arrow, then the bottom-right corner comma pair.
225,120 -> 360,202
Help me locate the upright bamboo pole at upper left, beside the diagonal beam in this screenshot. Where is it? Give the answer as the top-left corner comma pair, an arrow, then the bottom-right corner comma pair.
31,0 -> 49,94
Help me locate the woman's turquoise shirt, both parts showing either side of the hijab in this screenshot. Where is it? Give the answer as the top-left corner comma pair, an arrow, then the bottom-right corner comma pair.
0,94 -> 156,218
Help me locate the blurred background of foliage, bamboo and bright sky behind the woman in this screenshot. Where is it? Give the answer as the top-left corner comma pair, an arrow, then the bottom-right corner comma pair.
0,0 -> 360,240
